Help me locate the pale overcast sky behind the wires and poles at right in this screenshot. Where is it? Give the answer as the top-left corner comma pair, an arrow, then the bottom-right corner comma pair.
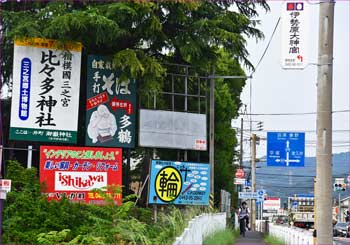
233,1 -> 350,160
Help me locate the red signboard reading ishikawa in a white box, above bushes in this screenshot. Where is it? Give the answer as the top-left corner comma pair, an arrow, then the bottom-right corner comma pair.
40,146 -> 122,205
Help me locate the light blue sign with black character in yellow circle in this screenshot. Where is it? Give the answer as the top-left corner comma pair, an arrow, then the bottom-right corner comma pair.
148,160 -> 210,205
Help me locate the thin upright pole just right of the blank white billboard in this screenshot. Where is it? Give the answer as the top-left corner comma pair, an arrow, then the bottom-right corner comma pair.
209,66 -> 215,208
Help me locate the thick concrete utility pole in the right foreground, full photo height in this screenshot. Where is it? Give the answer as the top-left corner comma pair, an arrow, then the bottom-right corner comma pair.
316,0 -> 334,244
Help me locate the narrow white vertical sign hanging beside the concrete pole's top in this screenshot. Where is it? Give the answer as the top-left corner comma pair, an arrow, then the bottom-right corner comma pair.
281,0 -> 309,69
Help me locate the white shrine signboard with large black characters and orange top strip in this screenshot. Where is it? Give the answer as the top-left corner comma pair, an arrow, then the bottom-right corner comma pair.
10,38 -> 82,143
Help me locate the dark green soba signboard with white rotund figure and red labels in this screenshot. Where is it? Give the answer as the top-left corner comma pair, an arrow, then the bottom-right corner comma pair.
85,55 -> 136,148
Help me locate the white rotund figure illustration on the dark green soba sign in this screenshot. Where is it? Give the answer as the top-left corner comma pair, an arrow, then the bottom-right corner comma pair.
87,104 -> 117,144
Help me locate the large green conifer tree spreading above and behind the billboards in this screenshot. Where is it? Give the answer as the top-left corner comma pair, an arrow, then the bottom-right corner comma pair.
1,0 -> 268,203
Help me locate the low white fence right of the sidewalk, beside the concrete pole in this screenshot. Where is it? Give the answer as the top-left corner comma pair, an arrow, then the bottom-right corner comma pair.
268,223 -> 313,245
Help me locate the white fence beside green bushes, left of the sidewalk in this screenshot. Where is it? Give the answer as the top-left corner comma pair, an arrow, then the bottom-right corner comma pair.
173,213 -> 226,245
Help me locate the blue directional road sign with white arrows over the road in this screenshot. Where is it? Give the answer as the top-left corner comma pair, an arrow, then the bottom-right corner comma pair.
266,132 -> 305,167
